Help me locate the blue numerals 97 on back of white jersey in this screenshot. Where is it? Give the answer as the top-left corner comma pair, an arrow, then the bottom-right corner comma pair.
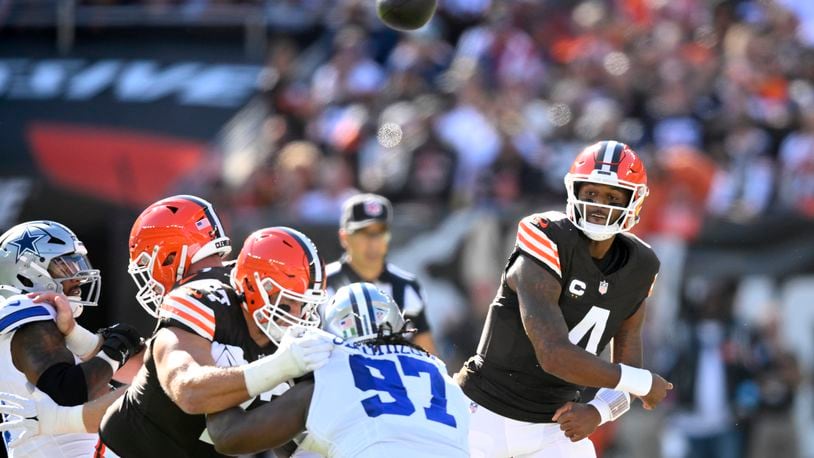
349,355 -> 457,428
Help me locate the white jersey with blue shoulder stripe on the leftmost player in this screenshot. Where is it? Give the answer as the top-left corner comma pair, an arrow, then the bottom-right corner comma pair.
0,295 -> 105,458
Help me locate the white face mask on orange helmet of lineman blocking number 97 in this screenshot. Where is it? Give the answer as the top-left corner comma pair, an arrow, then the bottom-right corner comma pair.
253,272 -> 328,345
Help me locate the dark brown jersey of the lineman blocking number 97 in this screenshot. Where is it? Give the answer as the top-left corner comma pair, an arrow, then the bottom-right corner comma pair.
100,267 -> 276,457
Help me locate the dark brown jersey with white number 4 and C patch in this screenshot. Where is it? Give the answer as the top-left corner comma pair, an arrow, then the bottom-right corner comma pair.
459,212 -> 659,423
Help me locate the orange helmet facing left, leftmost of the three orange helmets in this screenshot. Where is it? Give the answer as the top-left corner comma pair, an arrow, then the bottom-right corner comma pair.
127,195 -> 232,317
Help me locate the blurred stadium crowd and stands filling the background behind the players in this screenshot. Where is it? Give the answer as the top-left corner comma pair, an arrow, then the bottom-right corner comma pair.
0,0 -> 814,458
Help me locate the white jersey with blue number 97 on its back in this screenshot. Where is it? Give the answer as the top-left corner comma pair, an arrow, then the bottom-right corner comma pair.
303,343 -> 470,458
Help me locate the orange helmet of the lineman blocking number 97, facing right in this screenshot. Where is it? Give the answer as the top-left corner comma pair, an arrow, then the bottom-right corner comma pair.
232,227 -> 327,344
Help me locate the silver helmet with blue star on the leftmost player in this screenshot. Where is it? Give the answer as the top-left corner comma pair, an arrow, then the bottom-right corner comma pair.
0,221 -> 102,317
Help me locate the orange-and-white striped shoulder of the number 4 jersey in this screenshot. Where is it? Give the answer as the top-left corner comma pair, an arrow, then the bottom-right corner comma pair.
515,212 -> 568,278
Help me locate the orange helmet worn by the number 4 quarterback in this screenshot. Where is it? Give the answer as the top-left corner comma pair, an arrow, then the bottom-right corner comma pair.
565,140 -> 649,241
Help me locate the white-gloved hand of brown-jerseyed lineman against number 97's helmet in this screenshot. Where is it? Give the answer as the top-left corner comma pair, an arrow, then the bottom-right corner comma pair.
275,327 -> 334,378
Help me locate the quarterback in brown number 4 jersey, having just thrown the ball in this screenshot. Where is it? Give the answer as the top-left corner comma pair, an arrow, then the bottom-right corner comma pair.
457,141 -> 672,458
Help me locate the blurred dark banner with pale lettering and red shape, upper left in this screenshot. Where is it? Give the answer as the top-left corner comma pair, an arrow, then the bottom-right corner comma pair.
0,30 -> 262,207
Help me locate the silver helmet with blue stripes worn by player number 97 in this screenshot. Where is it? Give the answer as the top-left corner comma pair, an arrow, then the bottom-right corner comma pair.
322,283 -> 405,343
